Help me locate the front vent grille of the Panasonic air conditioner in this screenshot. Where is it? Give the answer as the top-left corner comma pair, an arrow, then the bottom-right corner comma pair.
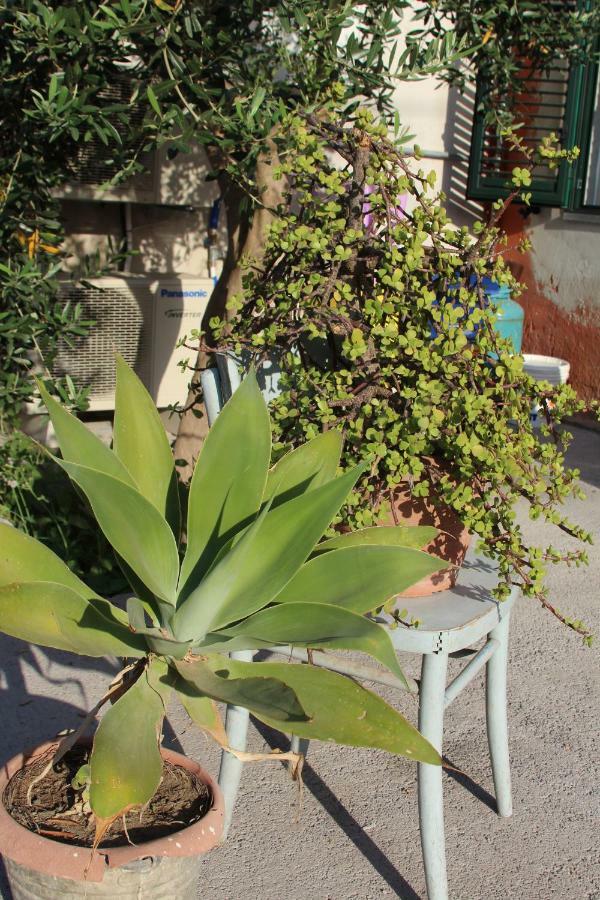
53,286 -> 152,400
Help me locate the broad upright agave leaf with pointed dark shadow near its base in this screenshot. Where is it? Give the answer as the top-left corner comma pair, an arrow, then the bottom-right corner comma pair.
179,372 -> 271,596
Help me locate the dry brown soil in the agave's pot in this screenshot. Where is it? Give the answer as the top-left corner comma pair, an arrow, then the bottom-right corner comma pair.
3,746 -> 212,847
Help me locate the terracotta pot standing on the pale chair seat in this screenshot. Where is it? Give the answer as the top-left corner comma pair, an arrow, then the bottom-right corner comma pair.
385,487 -> 471,597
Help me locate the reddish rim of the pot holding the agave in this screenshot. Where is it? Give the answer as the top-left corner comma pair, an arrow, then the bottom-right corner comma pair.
0,740 -> 225,882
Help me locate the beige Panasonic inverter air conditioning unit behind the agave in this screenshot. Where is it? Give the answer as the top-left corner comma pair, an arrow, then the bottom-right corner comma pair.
53,275 -> 213,411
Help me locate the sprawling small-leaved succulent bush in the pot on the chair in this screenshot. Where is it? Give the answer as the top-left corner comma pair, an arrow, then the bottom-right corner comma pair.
211,110 -> 591,639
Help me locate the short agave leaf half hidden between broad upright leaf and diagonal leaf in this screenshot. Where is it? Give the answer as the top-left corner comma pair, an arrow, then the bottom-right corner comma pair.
263,430 -> 343,508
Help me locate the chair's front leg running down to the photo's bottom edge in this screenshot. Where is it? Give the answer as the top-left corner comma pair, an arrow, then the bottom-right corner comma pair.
418,653 -> 448,900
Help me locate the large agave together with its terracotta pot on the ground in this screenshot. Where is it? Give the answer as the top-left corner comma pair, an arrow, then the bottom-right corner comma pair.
0,359 -> 440,898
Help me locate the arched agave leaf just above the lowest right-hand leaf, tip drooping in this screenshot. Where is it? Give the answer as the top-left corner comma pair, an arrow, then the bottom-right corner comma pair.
211,603 -> 406,684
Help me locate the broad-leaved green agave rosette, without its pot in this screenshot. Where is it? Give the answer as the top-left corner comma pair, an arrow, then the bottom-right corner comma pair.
0,359 -> 443,840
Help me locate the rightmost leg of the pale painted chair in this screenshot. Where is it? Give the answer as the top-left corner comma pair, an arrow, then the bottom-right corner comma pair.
485,615 -> 512,816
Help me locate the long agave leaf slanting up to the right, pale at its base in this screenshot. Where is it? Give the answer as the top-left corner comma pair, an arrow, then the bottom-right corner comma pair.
173,465 -> 365,641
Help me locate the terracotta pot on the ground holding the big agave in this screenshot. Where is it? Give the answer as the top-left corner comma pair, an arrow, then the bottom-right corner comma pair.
0,741 -> 224,900
